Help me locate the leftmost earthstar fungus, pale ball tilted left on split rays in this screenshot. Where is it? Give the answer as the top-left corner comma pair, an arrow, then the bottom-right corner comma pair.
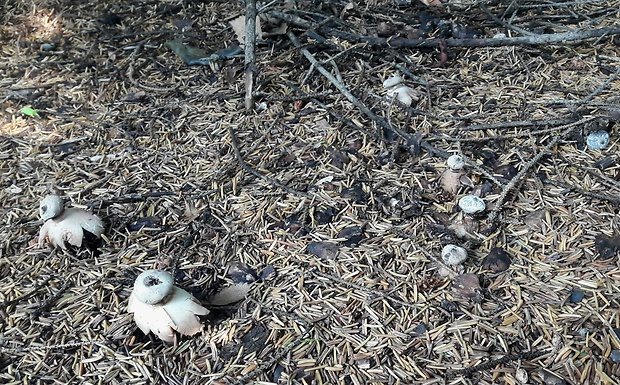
39,195 -> 104,249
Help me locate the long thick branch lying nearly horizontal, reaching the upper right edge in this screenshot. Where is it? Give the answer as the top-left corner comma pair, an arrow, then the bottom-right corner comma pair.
320,27 -> 620,48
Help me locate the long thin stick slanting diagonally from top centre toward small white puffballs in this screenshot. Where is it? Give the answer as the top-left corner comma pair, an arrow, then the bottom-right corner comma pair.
286,32 -> 450,158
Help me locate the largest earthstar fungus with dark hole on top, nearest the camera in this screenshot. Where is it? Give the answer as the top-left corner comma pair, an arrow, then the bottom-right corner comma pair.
127,270 -> 209,343
